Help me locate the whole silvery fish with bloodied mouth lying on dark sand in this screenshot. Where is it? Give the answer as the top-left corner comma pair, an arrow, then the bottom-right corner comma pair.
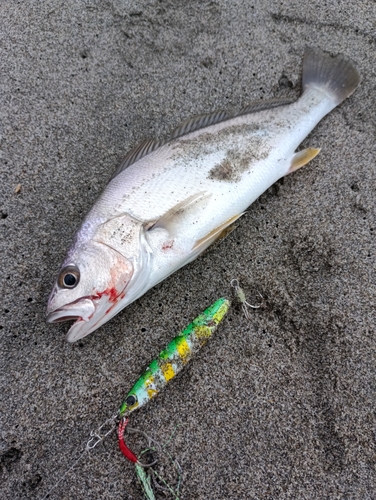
47,48 -> 360,342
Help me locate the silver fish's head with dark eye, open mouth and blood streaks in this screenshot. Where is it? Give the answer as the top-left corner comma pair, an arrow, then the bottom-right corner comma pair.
47,240 -> 134,342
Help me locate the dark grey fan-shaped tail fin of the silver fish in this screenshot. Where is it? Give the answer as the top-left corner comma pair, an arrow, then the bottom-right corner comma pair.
303,47 -> 360,107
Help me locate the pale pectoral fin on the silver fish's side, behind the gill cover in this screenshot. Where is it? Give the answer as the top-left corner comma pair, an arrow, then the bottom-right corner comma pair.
145,192 -> 211,237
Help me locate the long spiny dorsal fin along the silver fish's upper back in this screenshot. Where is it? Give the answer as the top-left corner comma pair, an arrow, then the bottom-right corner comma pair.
110,98 -> 295,181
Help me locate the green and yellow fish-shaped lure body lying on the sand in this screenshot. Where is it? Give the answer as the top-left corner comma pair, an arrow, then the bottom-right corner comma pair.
119,297 -> 230,418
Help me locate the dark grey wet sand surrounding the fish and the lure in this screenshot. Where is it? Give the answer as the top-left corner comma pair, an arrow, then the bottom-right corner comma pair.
0,0 -> 376,500
